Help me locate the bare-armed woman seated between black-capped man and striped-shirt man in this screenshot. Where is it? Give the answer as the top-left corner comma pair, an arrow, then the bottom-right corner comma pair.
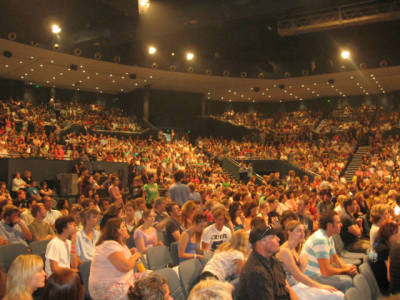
277,220 -> 344,300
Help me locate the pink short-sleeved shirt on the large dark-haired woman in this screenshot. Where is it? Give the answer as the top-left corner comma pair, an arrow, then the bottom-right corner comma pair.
89,241 -> 134,286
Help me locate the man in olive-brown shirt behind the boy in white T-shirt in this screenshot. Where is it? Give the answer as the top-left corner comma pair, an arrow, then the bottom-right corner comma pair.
28,203 -> 54,241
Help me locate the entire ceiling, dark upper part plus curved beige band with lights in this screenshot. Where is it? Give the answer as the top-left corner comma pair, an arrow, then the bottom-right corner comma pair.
0,0 -> 400,101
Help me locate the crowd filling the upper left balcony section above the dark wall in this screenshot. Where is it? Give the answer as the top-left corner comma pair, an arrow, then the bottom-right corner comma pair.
0,98 -> 142,161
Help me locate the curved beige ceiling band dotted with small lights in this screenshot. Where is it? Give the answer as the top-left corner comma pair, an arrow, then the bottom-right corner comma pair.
0,39 -> 400,102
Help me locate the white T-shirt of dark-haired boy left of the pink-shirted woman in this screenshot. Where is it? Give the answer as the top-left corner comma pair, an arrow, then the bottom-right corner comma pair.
44,236 -> 71,276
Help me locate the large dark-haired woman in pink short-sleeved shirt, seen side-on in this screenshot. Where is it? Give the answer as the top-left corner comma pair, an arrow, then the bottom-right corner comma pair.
89,218 -> 141,300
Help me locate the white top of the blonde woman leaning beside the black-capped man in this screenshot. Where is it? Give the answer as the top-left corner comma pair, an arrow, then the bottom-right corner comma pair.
203,250 -> 244,281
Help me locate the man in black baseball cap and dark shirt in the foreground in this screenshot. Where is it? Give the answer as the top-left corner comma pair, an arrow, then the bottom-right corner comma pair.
238,225 -> 297,300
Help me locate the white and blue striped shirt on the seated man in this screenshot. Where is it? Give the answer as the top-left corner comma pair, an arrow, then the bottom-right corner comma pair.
302,229 -> 336,276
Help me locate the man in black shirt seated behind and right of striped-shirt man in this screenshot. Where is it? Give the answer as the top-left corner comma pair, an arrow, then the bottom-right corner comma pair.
340,199 -> 369,252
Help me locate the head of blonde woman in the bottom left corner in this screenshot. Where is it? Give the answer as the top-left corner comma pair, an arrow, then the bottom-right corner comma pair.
3,255 -> 46,300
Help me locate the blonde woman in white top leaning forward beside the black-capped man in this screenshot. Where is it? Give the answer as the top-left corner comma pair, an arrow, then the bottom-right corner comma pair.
200,229 -> 249,281
